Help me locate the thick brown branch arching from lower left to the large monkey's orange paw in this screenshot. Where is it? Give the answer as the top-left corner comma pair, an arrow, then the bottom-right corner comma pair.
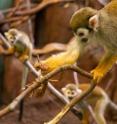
0,65 -> 92,117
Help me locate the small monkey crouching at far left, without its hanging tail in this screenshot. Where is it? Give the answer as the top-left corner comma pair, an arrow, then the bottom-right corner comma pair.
5,29 -> 33,62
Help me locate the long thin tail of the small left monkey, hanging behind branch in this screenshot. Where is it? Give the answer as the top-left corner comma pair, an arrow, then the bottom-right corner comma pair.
18,65 -> 29,121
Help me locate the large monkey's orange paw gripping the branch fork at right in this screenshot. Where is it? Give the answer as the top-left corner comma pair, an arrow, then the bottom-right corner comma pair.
91,68 -> 105,82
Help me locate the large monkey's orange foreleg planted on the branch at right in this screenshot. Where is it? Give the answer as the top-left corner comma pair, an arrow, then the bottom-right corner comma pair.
91,53 -> 117,81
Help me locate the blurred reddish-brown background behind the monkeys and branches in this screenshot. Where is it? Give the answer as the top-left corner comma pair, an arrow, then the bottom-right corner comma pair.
0,0 -> 117,124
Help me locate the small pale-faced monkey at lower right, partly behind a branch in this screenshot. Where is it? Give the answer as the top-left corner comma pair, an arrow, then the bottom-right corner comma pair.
62,83 -> 117,124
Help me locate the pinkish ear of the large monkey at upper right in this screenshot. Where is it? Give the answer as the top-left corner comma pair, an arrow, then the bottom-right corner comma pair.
89,15 -> 99,31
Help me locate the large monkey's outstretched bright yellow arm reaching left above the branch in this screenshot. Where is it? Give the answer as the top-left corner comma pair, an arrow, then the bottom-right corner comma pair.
35,40 -> 79,72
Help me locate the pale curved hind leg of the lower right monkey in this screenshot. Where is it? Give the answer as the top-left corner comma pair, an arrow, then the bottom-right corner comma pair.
94,97 -> 107,124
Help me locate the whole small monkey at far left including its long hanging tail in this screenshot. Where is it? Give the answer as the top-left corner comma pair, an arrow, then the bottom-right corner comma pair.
4,29 -> 33,121
